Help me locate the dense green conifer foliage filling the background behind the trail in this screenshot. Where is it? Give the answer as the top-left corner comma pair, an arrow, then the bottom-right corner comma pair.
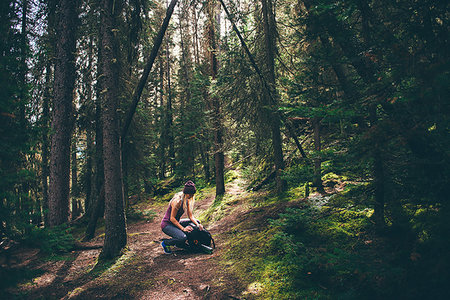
0,0 -> 450,298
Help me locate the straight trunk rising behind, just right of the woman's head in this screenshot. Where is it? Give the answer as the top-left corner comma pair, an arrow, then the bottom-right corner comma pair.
207,1 -> 225,196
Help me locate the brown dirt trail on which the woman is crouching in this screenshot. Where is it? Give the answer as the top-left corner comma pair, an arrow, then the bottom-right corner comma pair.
3,179 -> 248,299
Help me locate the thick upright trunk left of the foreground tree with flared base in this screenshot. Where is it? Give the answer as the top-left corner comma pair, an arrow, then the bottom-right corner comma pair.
48,0 -> 77,226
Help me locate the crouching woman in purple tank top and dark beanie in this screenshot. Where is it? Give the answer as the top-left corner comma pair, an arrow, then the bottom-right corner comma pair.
161,180 -> 203,254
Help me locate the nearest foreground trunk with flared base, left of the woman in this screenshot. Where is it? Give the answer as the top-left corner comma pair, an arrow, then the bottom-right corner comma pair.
100,0 -> 127,259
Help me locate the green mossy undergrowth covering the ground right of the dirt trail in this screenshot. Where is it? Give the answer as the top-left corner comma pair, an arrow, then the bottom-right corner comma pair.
222,187 -> 448,299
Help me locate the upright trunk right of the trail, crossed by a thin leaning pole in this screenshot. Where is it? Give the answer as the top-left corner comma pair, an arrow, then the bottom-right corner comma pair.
262,0 -> 286,192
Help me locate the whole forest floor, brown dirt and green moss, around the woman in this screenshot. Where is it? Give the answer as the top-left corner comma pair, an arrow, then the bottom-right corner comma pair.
3,171 -> 448,299
